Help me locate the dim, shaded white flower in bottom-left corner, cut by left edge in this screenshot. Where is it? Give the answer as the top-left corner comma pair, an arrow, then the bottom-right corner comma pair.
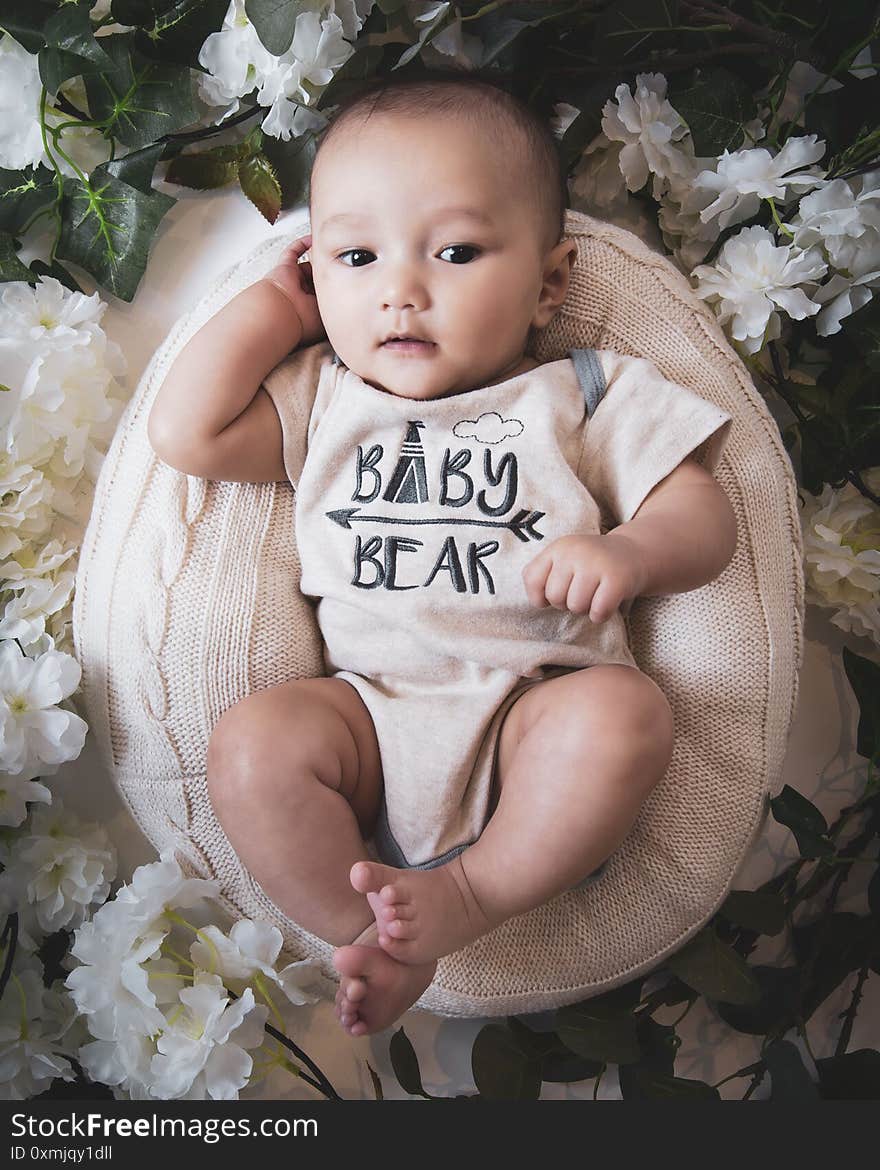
0,962 -> 74,1101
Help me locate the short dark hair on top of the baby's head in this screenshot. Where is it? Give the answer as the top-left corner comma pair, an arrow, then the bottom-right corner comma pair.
315,69 -> 568,249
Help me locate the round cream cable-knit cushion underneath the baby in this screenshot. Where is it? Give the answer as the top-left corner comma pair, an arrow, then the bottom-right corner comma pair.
74,213 -> 803,1016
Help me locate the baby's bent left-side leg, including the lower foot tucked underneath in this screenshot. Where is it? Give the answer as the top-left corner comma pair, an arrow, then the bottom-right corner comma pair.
207,679 -> 435,1035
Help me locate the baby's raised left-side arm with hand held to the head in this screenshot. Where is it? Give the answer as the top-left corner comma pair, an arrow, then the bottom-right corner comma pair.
147,236 -> 324,483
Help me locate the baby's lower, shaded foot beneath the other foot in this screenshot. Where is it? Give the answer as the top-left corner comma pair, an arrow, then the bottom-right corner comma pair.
334,925 -> 436,1035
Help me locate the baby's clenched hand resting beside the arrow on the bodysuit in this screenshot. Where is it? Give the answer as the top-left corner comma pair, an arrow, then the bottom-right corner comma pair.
523,536 -> 644,622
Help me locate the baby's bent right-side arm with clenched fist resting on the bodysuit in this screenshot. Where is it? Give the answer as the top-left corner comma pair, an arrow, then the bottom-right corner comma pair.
523,456 -> 736,622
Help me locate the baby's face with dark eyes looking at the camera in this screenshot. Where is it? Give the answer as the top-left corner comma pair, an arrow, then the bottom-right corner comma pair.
310,115 -> 564,399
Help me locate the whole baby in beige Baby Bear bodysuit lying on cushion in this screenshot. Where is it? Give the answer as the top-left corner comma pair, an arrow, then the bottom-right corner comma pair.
150,75 -> 736,1035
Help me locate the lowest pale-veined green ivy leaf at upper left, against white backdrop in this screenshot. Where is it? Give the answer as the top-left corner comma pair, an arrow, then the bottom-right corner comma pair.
56,167 -> 174,301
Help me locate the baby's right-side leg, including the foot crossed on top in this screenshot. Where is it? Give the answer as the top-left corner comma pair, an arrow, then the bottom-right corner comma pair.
351,665 -> 673,963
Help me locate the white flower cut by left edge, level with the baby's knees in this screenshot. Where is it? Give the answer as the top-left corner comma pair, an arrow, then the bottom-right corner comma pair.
0,641 -> 88,779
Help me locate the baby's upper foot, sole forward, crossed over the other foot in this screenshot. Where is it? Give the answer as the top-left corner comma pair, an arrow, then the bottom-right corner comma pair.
350,858 -> 502,964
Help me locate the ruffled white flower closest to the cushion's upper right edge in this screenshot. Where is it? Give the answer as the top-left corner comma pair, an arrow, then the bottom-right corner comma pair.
693,227 -> 826,353
